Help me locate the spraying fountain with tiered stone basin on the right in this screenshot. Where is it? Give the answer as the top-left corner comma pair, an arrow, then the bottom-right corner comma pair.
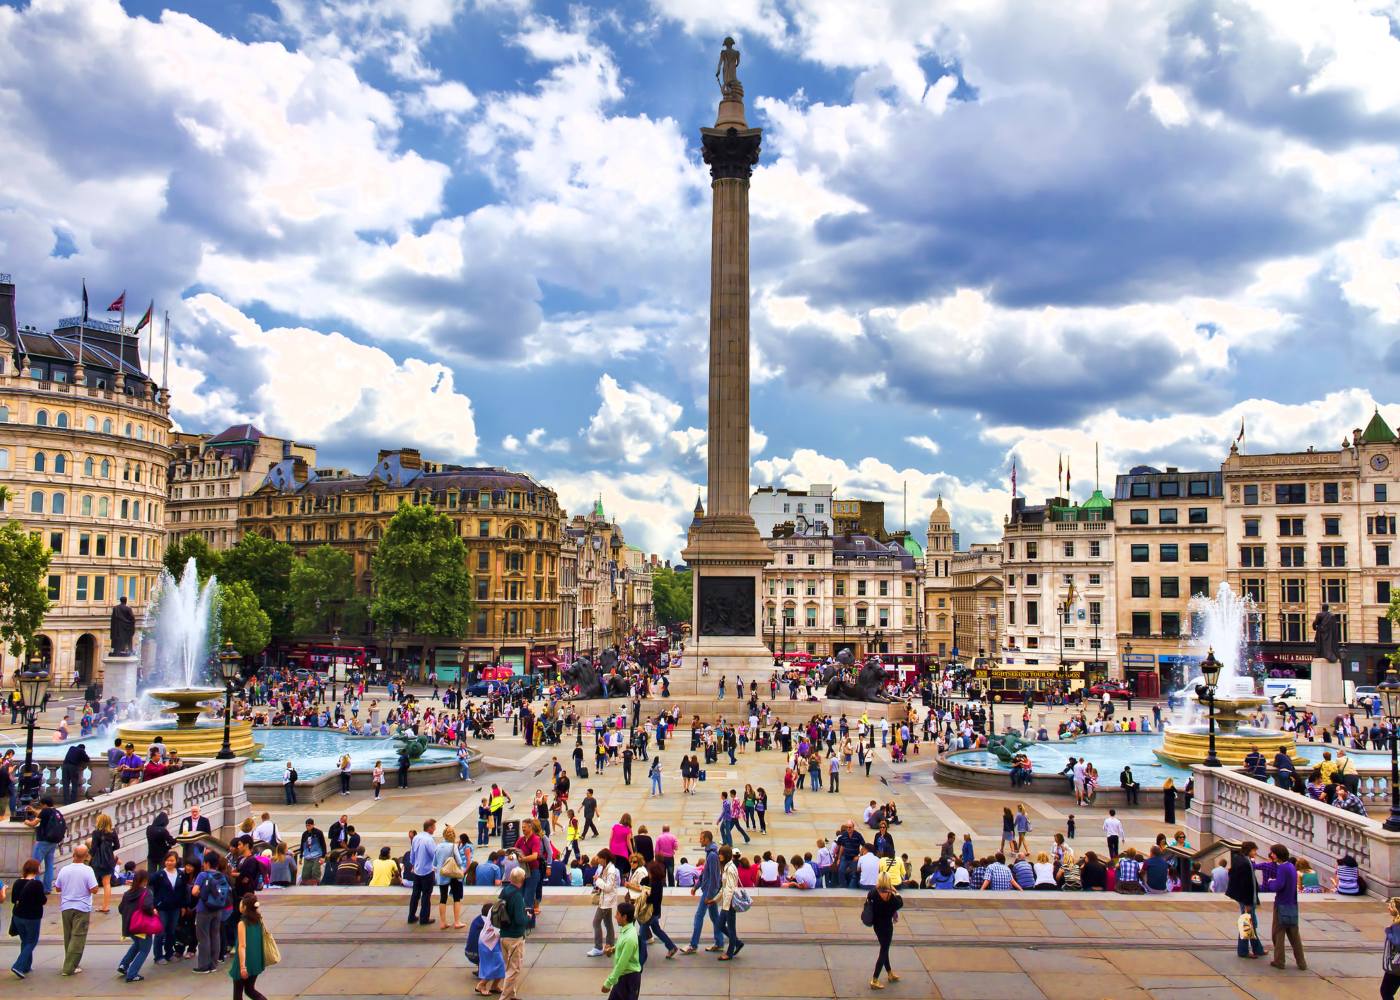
1155,583 -> 1303,766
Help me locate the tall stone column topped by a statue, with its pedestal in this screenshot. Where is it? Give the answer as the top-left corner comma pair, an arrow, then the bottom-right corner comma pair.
671,38 -> 773,696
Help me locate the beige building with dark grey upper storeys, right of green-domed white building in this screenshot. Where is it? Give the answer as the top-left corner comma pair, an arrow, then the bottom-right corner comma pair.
1113,465 -> 1225,695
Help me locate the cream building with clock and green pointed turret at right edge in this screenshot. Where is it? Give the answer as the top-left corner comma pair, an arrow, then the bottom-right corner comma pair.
1222,412 -> 1400,683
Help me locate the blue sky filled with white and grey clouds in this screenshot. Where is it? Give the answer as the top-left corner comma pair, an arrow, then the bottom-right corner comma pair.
0,0 -> 1400,555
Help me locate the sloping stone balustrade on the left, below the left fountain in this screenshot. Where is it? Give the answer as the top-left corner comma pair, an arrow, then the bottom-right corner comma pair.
0,758 -> 251,880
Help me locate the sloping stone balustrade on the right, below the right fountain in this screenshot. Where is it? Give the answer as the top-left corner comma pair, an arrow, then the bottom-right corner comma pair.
1186,765 -> 1400,896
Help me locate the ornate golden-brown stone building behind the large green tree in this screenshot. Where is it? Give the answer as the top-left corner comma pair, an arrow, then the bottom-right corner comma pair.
238,448 -> 571,676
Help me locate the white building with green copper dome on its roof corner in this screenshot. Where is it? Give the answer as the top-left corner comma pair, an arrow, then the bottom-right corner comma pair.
1001,490 -> 1121,681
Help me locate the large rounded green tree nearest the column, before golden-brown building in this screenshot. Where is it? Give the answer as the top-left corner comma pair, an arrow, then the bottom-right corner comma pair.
370,504 -> 476,636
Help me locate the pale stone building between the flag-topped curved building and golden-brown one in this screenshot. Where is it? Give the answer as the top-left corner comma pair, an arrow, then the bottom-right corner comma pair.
165,423 -> 316,550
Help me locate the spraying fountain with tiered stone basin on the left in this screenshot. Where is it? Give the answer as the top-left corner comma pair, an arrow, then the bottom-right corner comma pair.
116,559 -> 258,758
